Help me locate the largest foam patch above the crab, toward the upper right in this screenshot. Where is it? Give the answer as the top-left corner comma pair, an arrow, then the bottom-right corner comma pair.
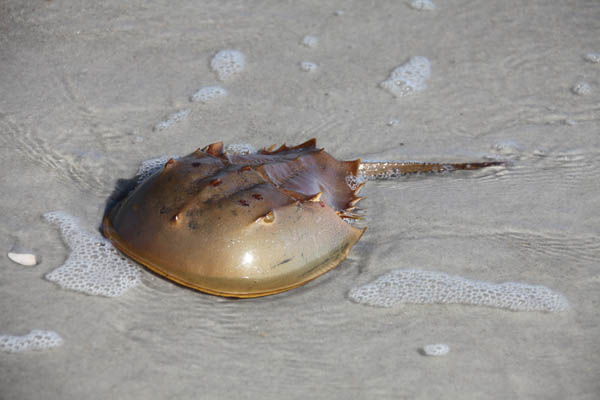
379,56 -> 431,97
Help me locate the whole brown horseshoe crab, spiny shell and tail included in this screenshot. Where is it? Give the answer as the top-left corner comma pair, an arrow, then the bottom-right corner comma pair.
104,139 -> 501,297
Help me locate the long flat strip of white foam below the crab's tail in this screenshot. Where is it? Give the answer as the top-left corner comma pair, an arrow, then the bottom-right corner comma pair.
349,269 -> 568,312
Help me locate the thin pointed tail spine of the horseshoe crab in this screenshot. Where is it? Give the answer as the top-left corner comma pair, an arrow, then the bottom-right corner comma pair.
358,161 -> 506,180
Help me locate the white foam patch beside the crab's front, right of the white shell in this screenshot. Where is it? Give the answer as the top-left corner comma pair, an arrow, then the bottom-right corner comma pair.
44,211 -> 140,297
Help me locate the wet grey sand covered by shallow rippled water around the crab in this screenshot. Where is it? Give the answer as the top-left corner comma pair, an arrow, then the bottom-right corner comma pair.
0,0 -> 600,400
